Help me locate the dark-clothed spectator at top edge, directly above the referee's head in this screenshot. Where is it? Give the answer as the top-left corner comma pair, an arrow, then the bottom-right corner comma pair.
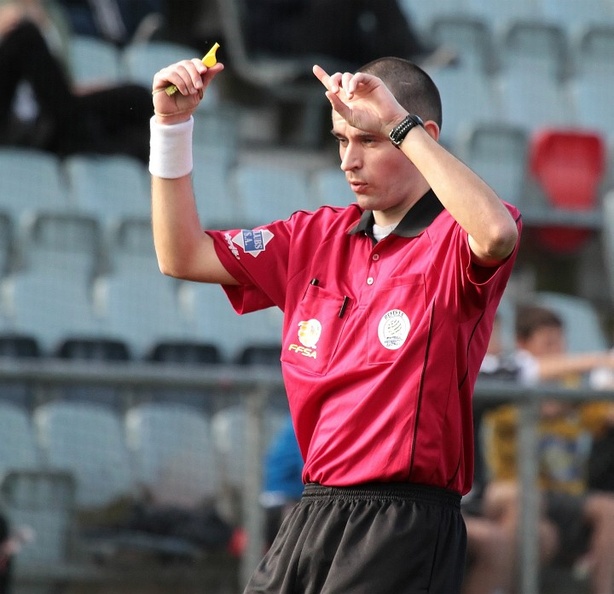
246,0 -> 456,71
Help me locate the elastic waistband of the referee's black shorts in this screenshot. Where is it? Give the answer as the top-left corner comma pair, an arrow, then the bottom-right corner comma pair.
303,483 -> 461,509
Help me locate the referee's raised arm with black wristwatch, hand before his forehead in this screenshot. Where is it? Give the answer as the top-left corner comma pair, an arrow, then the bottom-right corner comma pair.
314,66 -> 518,265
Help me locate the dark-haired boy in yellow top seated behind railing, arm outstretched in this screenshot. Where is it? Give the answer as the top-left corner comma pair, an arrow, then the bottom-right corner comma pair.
483,305 -> 614,594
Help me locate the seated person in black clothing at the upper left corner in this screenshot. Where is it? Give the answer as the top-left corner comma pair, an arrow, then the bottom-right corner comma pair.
0,0 -> 153,163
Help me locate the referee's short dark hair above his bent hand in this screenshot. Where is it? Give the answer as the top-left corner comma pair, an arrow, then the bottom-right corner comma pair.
358,57 -> 443,128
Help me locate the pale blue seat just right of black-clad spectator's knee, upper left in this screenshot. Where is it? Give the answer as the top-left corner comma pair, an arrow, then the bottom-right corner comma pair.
68,34 -> 121,85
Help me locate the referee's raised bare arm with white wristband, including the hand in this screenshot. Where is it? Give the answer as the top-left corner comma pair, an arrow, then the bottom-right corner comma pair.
150,59 -> 236,284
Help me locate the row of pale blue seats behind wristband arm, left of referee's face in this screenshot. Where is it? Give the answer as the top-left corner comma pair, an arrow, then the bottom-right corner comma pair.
0,145 -> 354,227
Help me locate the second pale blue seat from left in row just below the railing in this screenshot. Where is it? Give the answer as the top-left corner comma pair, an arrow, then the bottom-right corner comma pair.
33,401 -> 135,510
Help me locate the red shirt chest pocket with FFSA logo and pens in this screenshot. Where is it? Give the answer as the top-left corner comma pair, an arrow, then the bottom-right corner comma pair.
281,285 -> 352,375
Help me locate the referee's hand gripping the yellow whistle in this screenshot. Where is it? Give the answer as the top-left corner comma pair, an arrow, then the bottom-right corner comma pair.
152,58 -> 224,124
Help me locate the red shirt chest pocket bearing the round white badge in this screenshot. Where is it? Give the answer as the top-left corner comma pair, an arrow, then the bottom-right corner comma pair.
367,274 -> 428,365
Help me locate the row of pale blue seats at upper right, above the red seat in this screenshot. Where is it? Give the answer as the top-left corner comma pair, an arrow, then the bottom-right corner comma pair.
422,17 -> 614,146
